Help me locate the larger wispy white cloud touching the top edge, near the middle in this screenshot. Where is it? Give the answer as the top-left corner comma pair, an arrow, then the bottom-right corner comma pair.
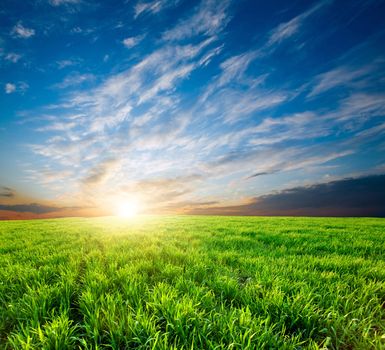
163,0 -> 230,41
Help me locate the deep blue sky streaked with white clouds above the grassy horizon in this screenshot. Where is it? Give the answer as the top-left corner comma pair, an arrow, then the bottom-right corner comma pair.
0,0 -> 385,219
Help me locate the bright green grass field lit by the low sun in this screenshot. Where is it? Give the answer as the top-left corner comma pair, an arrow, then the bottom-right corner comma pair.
0,216 -> 385,350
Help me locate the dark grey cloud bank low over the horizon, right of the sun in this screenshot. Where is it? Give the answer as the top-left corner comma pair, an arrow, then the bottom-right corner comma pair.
191,174 -> 385,217
